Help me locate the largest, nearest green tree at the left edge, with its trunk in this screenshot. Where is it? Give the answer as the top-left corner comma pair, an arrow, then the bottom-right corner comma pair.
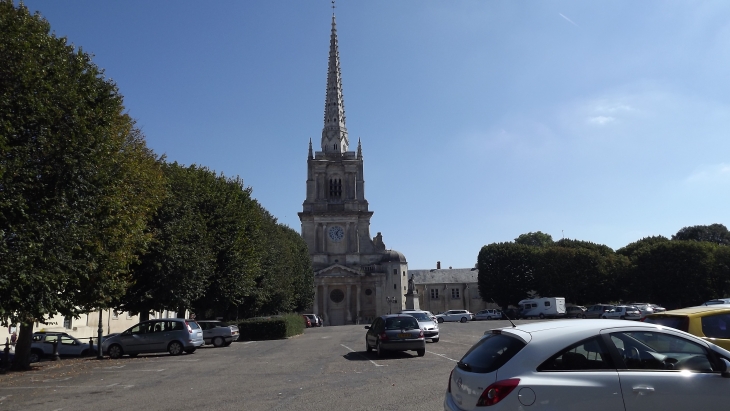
0,0 -> 162,374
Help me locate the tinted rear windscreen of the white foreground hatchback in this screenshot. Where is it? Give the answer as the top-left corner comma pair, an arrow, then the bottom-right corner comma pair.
458,334 -> 525,373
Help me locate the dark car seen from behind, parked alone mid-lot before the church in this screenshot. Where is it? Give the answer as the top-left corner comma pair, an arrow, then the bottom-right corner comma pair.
365,314 -> 426,357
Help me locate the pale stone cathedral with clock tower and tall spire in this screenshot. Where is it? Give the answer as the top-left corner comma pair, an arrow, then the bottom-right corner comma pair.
299,14 -> 408,325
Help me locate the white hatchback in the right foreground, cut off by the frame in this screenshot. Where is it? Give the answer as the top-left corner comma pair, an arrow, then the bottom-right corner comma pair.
444,319 -> 730,411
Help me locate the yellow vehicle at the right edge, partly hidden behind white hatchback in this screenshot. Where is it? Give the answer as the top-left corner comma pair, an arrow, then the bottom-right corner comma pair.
644,305 -> 730,350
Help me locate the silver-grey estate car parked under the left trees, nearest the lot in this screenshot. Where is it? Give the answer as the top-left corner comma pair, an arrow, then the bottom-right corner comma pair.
101,318 -> 204,358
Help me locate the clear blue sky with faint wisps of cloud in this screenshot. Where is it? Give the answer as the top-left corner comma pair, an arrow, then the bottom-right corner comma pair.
25,0 -> 730,269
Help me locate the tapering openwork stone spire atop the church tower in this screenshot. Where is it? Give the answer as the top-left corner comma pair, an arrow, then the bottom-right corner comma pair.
322,11 -> 350,153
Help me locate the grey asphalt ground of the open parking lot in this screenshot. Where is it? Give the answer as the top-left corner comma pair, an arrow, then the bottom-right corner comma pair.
0,321 -> 536,411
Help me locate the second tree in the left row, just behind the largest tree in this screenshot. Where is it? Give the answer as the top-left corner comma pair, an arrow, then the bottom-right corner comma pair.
121,163 -> 220,319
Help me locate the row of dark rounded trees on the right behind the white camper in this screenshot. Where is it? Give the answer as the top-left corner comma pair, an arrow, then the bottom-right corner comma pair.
477,229 -> 730,308
